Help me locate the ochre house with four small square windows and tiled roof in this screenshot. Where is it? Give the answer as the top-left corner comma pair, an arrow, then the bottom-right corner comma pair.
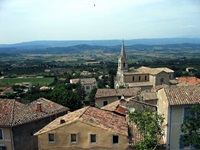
35,107 -> 129,150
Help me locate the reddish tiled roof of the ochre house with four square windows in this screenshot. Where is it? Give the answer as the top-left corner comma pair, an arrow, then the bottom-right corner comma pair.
35,106 -> 128,136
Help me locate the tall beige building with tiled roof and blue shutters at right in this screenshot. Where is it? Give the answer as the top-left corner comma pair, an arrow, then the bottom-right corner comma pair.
158,86 -> 200,150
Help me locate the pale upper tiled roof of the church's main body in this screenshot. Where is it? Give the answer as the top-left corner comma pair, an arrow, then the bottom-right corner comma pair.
137,66 -> 174,75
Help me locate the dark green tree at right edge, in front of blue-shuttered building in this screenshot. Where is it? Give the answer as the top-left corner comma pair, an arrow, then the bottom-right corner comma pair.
180,104 -> 200,149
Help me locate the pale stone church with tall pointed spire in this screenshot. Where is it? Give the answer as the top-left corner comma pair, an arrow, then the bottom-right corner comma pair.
115,41 -> 174,90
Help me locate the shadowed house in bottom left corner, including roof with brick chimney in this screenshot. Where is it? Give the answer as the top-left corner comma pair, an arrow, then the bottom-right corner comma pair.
0,98 -> 68,150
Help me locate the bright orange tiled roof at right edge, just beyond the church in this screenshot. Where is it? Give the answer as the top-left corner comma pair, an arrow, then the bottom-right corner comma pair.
177,77 -> 200,86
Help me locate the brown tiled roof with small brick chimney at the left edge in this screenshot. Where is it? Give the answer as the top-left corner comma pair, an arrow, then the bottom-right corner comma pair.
0,98 -> 68,126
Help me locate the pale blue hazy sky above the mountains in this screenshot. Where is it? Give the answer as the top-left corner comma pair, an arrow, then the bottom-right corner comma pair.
0,0 -> 200,44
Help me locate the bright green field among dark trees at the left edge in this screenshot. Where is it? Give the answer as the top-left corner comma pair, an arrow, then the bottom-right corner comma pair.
0,78 -> 54,87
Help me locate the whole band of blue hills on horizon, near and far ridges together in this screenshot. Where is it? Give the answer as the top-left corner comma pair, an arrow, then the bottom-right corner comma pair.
0,38 -> 200,54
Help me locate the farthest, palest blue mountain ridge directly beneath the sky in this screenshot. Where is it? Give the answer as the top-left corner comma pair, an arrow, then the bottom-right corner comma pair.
0,38 -> 200,49
